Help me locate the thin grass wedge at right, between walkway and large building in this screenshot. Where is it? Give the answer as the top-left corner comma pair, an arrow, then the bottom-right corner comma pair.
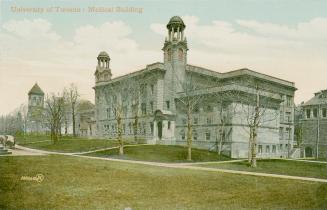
198,160 -> 327,179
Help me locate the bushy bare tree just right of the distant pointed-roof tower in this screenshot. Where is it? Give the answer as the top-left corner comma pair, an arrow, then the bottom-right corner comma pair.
45,93 -> 65,144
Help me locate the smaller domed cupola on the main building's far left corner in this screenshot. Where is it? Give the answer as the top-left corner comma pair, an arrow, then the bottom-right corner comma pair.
94,51 -> 112,83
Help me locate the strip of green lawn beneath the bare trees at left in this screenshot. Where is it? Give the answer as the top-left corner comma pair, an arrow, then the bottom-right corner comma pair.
17,136 -> 117,152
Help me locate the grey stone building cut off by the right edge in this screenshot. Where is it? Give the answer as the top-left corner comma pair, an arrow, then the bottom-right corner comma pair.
297,90 -> 327,157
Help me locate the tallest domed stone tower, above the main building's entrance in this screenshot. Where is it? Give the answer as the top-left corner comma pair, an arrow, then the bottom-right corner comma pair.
162,16 -> 188,92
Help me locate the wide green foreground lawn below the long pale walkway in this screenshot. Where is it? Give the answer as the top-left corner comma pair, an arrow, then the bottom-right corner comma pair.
0,155 -> 327,209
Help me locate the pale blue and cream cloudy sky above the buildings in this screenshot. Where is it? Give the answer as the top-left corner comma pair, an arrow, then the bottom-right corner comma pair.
0,0 -> 327,115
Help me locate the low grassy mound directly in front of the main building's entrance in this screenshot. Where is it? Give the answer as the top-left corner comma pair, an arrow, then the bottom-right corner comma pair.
87,145 -> 229,162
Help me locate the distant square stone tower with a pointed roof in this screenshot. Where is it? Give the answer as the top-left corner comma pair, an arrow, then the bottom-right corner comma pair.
26,83 -> 44,133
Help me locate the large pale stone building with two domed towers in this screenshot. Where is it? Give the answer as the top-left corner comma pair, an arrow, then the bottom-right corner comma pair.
94,16 -> 296,158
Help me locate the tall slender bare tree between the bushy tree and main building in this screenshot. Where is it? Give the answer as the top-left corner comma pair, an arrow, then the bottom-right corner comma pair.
64,83 -> 80,136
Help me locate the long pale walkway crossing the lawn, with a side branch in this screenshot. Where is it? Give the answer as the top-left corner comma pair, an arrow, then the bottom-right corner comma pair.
4,145 -> 327,183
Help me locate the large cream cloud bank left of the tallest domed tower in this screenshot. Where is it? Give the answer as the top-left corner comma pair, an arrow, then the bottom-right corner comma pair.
0,19 -> 161,113
